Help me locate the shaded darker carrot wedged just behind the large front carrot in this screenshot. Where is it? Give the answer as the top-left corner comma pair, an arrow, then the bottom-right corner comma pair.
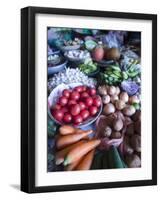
55,140 -> 86,165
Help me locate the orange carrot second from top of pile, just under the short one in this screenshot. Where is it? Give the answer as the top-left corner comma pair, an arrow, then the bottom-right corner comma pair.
56,130 -> 93,149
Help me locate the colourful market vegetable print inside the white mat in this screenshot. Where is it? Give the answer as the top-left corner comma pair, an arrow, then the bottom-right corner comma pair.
47,28 -> 141,172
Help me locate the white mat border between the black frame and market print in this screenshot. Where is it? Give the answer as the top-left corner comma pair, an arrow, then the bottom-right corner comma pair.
35,14 -> 152,186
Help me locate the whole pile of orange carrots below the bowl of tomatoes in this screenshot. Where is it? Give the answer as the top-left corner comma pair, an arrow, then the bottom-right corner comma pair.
56,125 -> 100,171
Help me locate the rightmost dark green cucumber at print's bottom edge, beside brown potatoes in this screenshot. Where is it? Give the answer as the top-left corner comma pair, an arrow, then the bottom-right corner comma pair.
108,146 -> 125,169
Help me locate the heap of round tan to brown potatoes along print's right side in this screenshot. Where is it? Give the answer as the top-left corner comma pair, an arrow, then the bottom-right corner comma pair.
98,85 -> 141,168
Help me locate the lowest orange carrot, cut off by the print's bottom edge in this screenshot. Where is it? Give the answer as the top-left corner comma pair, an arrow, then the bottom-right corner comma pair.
75,149 -> 95,170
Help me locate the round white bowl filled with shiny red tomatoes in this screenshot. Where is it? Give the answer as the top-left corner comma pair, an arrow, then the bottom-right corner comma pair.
48,83 -> 102,127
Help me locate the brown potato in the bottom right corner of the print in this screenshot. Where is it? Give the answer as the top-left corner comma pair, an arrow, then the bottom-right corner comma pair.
125,154 -> 141,168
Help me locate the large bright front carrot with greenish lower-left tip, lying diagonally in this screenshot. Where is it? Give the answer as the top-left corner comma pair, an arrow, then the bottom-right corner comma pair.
63,139 -> 100,166
